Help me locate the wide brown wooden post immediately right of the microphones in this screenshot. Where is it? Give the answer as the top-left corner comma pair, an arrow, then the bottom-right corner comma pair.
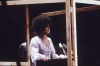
65,0 -> 72,66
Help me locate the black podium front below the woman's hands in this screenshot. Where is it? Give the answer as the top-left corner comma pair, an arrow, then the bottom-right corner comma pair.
36,59 -> 67,66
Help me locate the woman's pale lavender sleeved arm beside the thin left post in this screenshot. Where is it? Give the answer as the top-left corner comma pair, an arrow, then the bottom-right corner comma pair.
30,39 -> 45,62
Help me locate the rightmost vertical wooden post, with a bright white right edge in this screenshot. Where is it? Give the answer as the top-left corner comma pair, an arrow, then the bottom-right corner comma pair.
71,0 -> 78,66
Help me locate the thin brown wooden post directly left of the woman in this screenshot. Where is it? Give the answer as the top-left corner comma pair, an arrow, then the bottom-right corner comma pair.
26,4 -> 30,66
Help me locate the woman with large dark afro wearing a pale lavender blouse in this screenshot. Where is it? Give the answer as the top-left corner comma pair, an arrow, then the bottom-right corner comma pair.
30,15 -> 66,66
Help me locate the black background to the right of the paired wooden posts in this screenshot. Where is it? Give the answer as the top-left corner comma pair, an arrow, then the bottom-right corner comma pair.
76,3 -> 100,66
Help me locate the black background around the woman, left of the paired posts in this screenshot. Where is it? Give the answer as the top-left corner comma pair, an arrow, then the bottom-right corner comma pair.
0,2 -> 66,61
